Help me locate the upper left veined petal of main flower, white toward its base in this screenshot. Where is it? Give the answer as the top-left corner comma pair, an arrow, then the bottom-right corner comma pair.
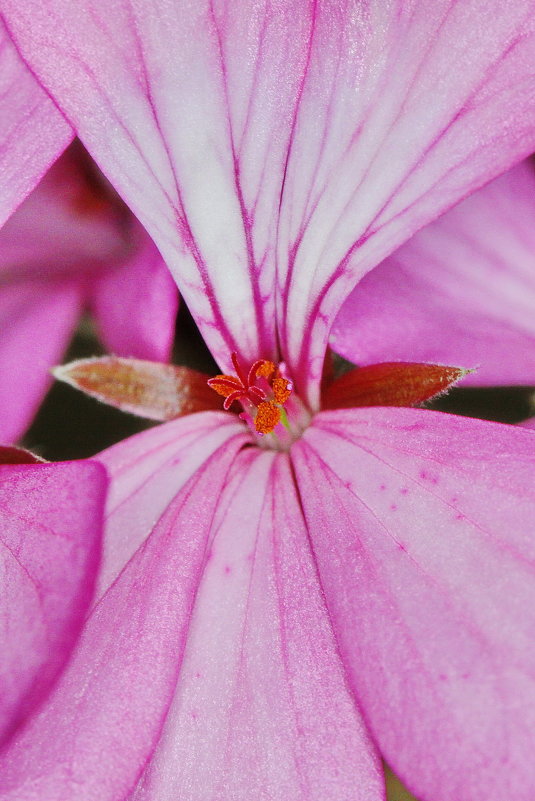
3,0 -> 311,366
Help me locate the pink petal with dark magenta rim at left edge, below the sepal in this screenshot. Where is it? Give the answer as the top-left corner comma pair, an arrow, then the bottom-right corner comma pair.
0,462 -> 106,741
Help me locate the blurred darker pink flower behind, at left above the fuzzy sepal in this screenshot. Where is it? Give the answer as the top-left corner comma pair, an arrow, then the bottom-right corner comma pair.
0,142 -> 177,442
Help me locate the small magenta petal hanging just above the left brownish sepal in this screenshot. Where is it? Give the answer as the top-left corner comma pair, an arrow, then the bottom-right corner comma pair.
92,221 -> 178,362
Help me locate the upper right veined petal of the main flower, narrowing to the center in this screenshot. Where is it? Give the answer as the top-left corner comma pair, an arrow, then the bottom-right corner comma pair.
278,0 -> 535,394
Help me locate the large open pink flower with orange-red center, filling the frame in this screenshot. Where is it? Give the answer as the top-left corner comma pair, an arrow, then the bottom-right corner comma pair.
0,0 -> 535,801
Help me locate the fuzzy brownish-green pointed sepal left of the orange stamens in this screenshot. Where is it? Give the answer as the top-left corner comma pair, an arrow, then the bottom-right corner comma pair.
53,356 -> 221,421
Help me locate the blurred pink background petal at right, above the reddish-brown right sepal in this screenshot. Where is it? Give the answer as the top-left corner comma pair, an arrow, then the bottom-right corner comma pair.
331,161 -> 535,384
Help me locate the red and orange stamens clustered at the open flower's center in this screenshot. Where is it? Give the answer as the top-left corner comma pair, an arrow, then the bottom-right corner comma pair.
208,353 -> 293,436
